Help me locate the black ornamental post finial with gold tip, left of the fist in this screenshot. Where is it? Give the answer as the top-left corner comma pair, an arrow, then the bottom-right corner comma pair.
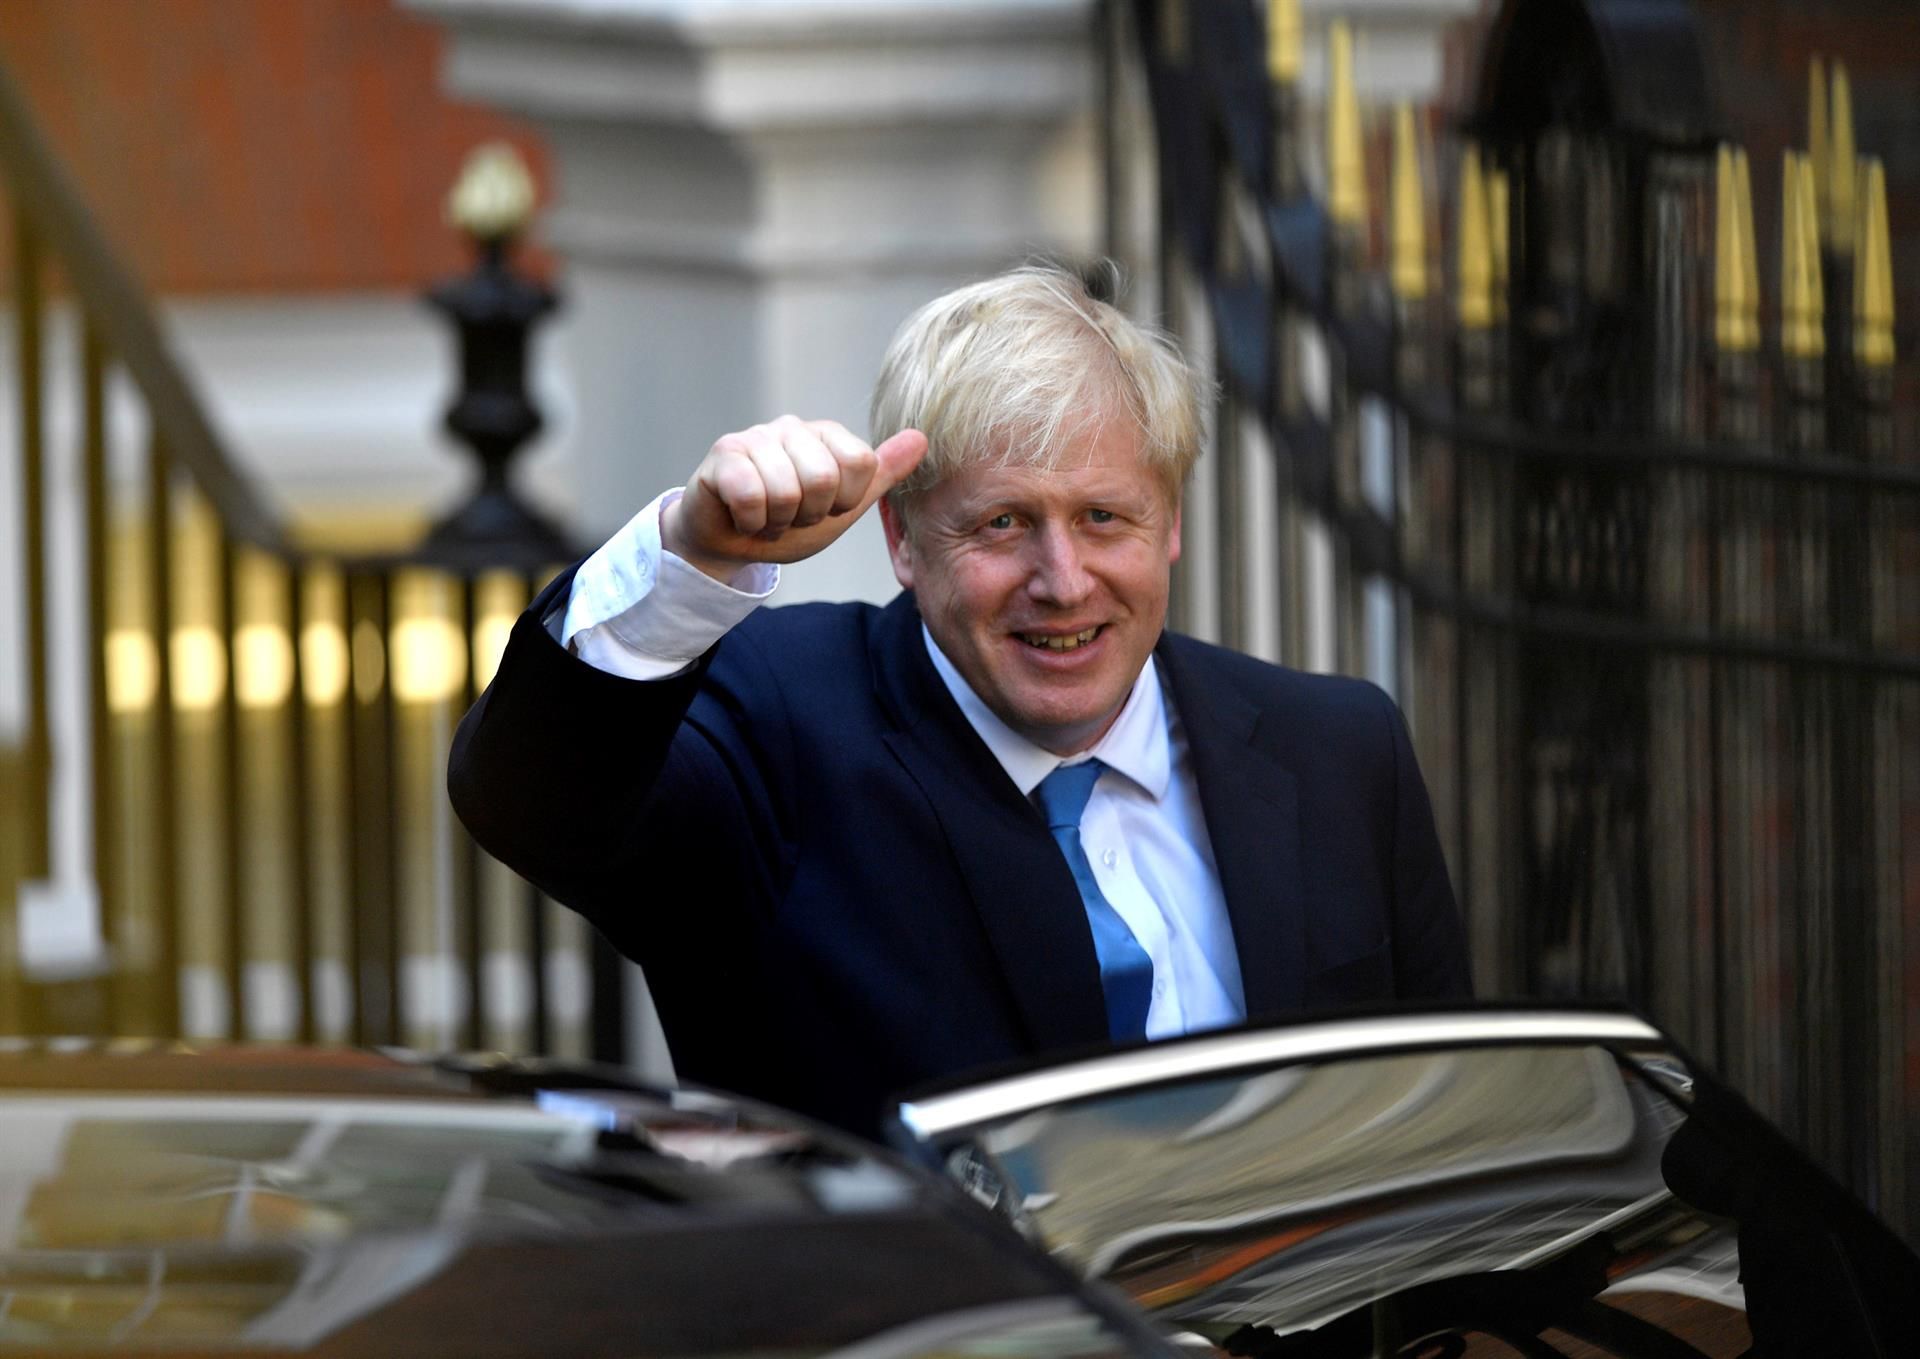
420,142 -> 578,570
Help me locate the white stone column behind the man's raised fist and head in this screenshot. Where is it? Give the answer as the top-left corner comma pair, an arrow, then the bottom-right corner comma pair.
407,0 -> 1098,601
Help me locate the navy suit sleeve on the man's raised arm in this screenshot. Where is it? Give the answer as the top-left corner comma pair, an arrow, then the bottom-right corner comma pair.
447,574 -> 787,940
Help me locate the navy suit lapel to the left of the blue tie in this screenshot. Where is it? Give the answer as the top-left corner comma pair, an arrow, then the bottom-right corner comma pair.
872,595 -> 1113,1048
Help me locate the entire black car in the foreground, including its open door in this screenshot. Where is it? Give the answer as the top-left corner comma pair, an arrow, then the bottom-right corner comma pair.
0,1010 -> 1920,1359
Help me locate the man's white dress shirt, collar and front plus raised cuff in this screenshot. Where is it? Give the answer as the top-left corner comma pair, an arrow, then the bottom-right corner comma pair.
557,489 -> 1246,1038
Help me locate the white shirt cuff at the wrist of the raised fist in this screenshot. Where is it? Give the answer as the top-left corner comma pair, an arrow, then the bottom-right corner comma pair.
559,488 -> 780,680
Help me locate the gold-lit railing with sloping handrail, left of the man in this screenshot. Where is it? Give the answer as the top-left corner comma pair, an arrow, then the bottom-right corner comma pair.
0,60 -> 626,1060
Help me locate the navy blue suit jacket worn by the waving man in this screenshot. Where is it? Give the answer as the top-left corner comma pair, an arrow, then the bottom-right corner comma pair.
449,574 -> 1469,1133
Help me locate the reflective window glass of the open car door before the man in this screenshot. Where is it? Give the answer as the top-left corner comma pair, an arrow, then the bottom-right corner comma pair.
913,1044 -> 1751,1357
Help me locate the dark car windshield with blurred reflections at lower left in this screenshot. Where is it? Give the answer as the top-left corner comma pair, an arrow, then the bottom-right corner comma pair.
0,1090 -> 1139,1359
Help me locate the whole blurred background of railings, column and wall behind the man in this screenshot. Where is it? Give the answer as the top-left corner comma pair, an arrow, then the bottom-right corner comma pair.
0,0 -> 1920,1240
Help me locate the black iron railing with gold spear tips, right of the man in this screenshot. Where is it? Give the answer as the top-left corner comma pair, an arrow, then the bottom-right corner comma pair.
1104,0 -> 1920,1236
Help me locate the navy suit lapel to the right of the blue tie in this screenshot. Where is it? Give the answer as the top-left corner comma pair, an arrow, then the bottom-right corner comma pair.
1156,635 -> 1306,1019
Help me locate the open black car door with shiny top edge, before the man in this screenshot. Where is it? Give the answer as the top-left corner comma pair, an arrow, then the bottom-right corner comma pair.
895,1008 -> 1920,1359
